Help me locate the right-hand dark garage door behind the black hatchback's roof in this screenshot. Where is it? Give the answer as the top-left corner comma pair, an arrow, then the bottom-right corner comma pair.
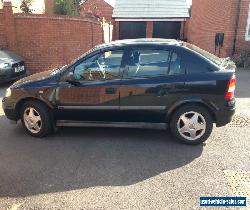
153,21 -> 181,39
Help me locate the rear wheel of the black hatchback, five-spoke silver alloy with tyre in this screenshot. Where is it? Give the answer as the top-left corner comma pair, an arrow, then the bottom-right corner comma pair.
170,105 -> 213,145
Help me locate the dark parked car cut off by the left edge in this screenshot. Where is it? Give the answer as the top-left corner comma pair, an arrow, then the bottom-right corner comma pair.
0,50 -> 26,83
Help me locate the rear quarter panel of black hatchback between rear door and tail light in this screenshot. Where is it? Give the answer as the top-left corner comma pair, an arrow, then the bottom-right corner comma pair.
182,48 -> 225,109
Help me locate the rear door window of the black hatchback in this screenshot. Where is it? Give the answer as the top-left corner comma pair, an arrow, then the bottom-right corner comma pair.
123,49 -> 181,78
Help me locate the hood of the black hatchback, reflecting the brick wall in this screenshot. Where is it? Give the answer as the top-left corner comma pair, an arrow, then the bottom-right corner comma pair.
11,70 -> 54,88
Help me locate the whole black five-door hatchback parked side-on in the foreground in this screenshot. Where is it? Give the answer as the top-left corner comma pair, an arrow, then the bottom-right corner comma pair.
3,39 -> 236,144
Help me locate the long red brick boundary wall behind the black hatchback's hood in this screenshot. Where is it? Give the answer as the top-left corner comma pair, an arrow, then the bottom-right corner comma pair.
0,1 -> 103,73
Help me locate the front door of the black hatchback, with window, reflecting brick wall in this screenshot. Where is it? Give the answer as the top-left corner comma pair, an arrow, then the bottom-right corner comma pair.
56,50 -> 123,121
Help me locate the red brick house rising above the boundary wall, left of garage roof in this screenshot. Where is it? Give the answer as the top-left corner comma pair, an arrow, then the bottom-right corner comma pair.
81,0 -> 114,22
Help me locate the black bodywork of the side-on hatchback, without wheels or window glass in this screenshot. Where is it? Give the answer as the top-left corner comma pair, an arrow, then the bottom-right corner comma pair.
3,40 -> 235,126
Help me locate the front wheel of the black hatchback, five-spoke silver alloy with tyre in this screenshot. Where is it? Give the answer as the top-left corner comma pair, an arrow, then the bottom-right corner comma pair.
20,101 -> 54,137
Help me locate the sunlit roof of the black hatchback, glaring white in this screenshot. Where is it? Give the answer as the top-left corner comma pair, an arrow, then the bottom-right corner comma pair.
94,38 -> 181,50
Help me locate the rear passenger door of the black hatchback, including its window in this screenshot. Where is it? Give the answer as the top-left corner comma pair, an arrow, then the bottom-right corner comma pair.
120,46 -> 185,122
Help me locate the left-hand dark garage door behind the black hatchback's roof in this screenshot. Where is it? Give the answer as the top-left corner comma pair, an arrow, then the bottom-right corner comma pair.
119,21 -> 147,39
